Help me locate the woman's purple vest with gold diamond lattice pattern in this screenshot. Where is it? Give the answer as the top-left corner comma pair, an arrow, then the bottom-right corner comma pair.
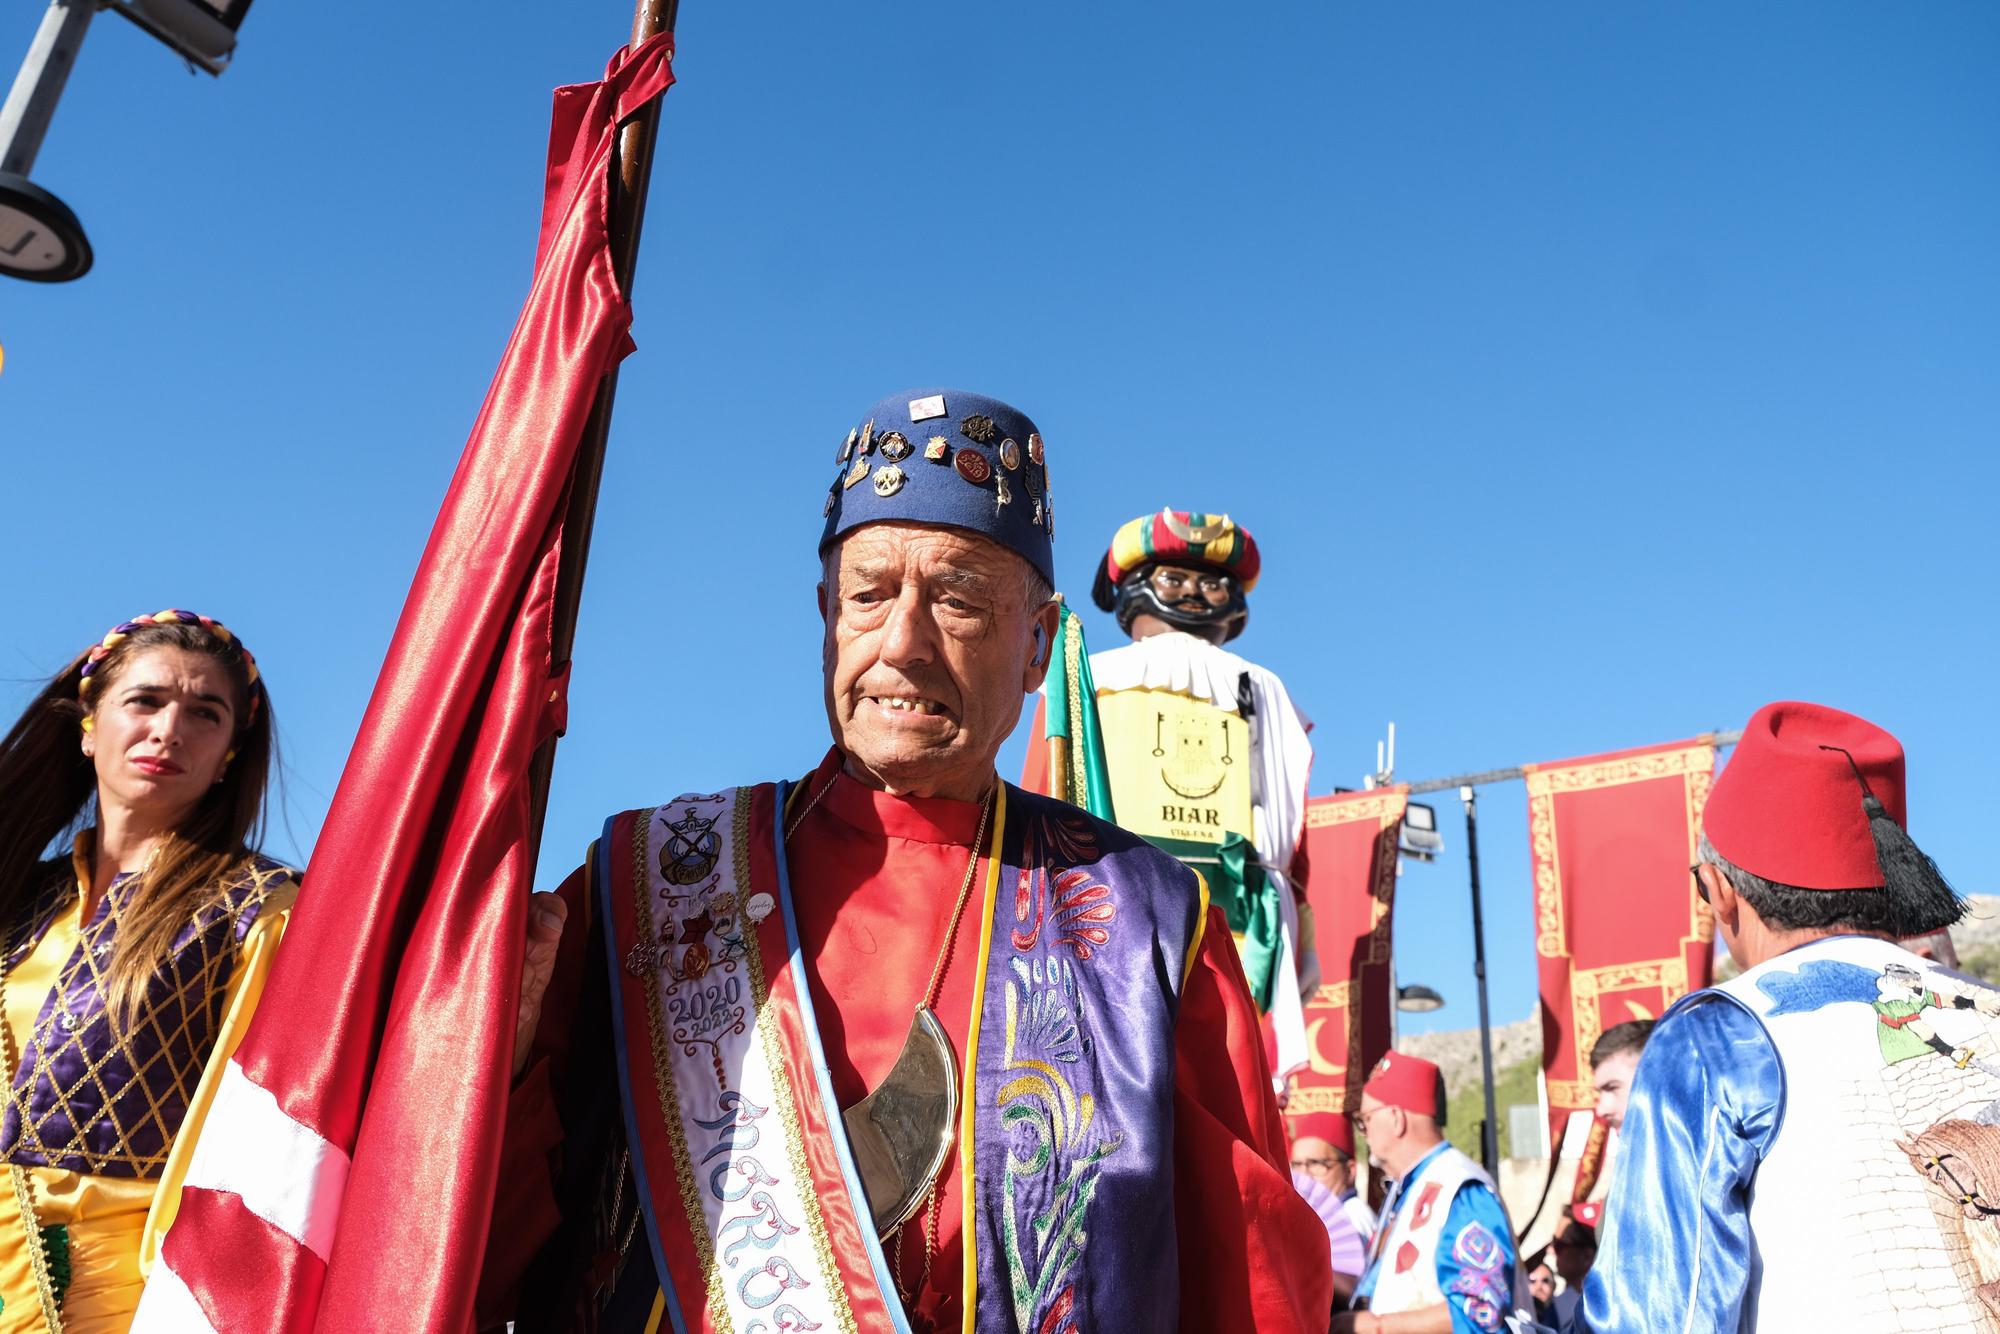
0,856 -> 296,1178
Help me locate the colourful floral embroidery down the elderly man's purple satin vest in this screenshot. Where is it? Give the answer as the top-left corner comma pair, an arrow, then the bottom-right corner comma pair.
994,814 -> 1124,1334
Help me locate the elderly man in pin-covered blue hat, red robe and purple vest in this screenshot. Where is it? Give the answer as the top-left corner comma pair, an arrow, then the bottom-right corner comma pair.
482,390 -> 1332,1334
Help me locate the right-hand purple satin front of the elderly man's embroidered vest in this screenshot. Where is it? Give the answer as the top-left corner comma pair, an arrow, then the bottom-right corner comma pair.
972,786 -> 1202,1334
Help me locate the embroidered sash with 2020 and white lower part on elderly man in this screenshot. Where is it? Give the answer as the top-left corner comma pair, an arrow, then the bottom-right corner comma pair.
626,788 -> 858,1334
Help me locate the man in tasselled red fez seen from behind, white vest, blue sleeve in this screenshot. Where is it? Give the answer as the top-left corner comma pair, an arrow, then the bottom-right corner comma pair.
1584,704 -> 2000,1334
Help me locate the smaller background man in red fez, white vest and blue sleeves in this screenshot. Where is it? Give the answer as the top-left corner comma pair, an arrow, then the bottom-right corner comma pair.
1332,1052 -> 1534,1334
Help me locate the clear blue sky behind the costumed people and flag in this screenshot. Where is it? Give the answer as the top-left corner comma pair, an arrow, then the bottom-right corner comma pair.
0,0 -> 2000,1028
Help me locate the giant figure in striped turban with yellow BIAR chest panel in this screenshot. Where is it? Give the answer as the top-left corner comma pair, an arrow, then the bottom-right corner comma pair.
1022,510 -> 1318,1076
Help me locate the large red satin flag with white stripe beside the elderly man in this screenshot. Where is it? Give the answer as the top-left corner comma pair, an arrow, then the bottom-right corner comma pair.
134,34 -> 674,1334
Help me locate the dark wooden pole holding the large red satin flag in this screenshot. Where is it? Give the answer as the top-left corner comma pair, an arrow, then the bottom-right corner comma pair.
528,0 -> 680,856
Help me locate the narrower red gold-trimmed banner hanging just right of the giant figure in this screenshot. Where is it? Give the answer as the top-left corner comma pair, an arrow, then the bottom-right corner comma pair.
1288,788 -> 1410,1114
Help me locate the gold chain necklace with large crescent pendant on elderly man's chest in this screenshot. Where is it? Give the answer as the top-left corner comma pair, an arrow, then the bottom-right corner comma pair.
784,774 -> 998,1308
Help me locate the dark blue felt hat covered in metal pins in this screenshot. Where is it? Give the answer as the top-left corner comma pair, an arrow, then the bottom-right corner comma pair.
820,390 -> 1056,584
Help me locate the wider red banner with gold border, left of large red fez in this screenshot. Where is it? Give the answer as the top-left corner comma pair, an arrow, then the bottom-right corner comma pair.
1522,736 -> 1716,1188
